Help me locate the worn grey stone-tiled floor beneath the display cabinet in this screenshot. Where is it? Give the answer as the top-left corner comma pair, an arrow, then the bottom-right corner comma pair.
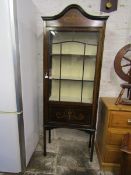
1,133 -> 112,175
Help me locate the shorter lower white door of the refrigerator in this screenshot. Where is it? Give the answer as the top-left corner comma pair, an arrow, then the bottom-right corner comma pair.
0,113 -> 21,173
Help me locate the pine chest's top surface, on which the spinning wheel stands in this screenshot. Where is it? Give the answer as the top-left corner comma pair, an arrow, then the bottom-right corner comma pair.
100,97 -> 131,111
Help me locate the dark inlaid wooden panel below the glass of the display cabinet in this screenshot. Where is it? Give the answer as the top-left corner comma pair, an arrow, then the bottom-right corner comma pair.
49,107 -> 92,124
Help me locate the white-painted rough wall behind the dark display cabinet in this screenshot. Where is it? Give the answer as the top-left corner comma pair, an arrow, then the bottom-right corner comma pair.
33,0 -> 131,138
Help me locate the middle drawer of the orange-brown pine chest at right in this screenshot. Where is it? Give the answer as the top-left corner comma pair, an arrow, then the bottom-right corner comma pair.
106,129 -> 131,146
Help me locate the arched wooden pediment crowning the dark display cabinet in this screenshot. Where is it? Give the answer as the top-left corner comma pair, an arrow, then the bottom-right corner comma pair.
42,4 -> 109,27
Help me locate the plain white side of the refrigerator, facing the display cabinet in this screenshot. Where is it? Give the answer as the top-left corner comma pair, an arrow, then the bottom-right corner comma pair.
17,0 -> 39,164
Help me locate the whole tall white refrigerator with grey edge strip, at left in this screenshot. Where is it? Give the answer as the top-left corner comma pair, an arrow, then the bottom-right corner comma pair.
0,0 -> 39,173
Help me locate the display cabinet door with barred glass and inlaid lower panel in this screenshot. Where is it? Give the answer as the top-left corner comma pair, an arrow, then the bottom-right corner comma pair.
44,29 -> 100,125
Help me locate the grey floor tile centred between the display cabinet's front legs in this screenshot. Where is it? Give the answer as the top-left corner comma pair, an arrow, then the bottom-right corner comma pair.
57,140 -> 89,168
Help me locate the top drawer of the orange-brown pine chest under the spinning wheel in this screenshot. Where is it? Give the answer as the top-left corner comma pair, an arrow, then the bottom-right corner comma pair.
109,111 -> 131,128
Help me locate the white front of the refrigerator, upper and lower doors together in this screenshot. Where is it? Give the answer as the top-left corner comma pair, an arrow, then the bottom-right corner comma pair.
0,0 -> 21,172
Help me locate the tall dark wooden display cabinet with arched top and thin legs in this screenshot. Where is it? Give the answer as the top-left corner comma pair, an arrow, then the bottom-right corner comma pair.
42,5 -> 108,160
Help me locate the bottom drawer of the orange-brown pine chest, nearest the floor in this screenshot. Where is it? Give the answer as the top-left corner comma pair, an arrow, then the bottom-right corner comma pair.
104,147 -> 122,163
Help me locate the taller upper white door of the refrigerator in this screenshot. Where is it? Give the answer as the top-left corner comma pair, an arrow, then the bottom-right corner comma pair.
0,0 -> 17,112
